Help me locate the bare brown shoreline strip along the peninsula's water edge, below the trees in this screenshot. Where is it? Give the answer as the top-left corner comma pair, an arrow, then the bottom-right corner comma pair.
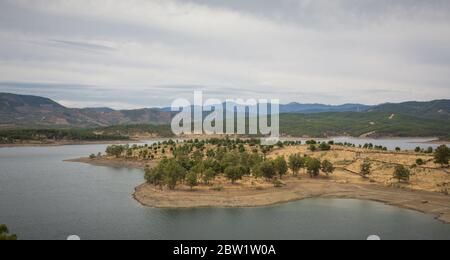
69,155 -> 450,223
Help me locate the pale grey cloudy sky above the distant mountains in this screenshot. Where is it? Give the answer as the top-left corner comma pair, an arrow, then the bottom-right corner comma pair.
0,0 -> 450,108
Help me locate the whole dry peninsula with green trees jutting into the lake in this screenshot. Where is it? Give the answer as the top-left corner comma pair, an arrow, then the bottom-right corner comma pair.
71,138 -> 450,223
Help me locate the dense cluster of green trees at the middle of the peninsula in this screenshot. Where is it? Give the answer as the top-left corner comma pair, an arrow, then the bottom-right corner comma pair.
145,139 -> 334,189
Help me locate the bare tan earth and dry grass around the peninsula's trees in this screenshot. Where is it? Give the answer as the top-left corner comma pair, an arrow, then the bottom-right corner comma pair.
67,146 -> 450,223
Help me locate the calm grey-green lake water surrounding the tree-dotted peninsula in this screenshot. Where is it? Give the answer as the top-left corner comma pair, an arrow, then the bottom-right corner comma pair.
0,137 -> 450,239
